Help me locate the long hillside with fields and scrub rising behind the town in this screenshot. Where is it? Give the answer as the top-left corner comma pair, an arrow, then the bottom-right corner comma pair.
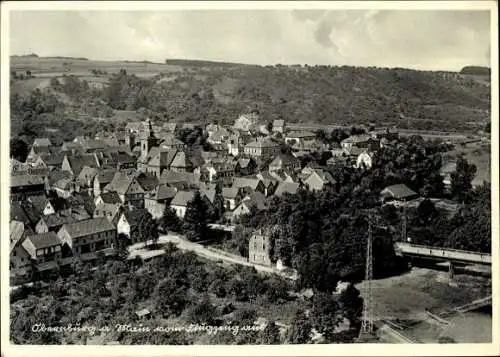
11,56 -> 490,142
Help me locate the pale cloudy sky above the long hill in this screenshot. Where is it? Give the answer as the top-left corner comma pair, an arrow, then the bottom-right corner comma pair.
9,9 -> 490,71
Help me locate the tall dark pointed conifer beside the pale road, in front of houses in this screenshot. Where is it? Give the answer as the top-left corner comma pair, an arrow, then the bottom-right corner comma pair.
183,191 -> 209,242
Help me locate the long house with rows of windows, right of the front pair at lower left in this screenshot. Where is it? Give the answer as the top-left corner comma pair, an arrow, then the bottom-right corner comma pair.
57,217 -> 116,257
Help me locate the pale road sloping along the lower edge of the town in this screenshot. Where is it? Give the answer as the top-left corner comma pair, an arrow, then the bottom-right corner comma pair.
129,234 -> 297,280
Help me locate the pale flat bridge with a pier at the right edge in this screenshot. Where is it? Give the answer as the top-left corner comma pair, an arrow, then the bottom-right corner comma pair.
394,242 -> 491,278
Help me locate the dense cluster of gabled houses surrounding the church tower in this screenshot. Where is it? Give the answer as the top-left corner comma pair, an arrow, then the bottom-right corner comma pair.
10,115 -> 426,275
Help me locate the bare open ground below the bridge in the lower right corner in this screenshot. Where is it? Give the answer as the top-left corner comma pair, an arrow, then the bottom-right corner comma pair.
358,268 -> 492,343
